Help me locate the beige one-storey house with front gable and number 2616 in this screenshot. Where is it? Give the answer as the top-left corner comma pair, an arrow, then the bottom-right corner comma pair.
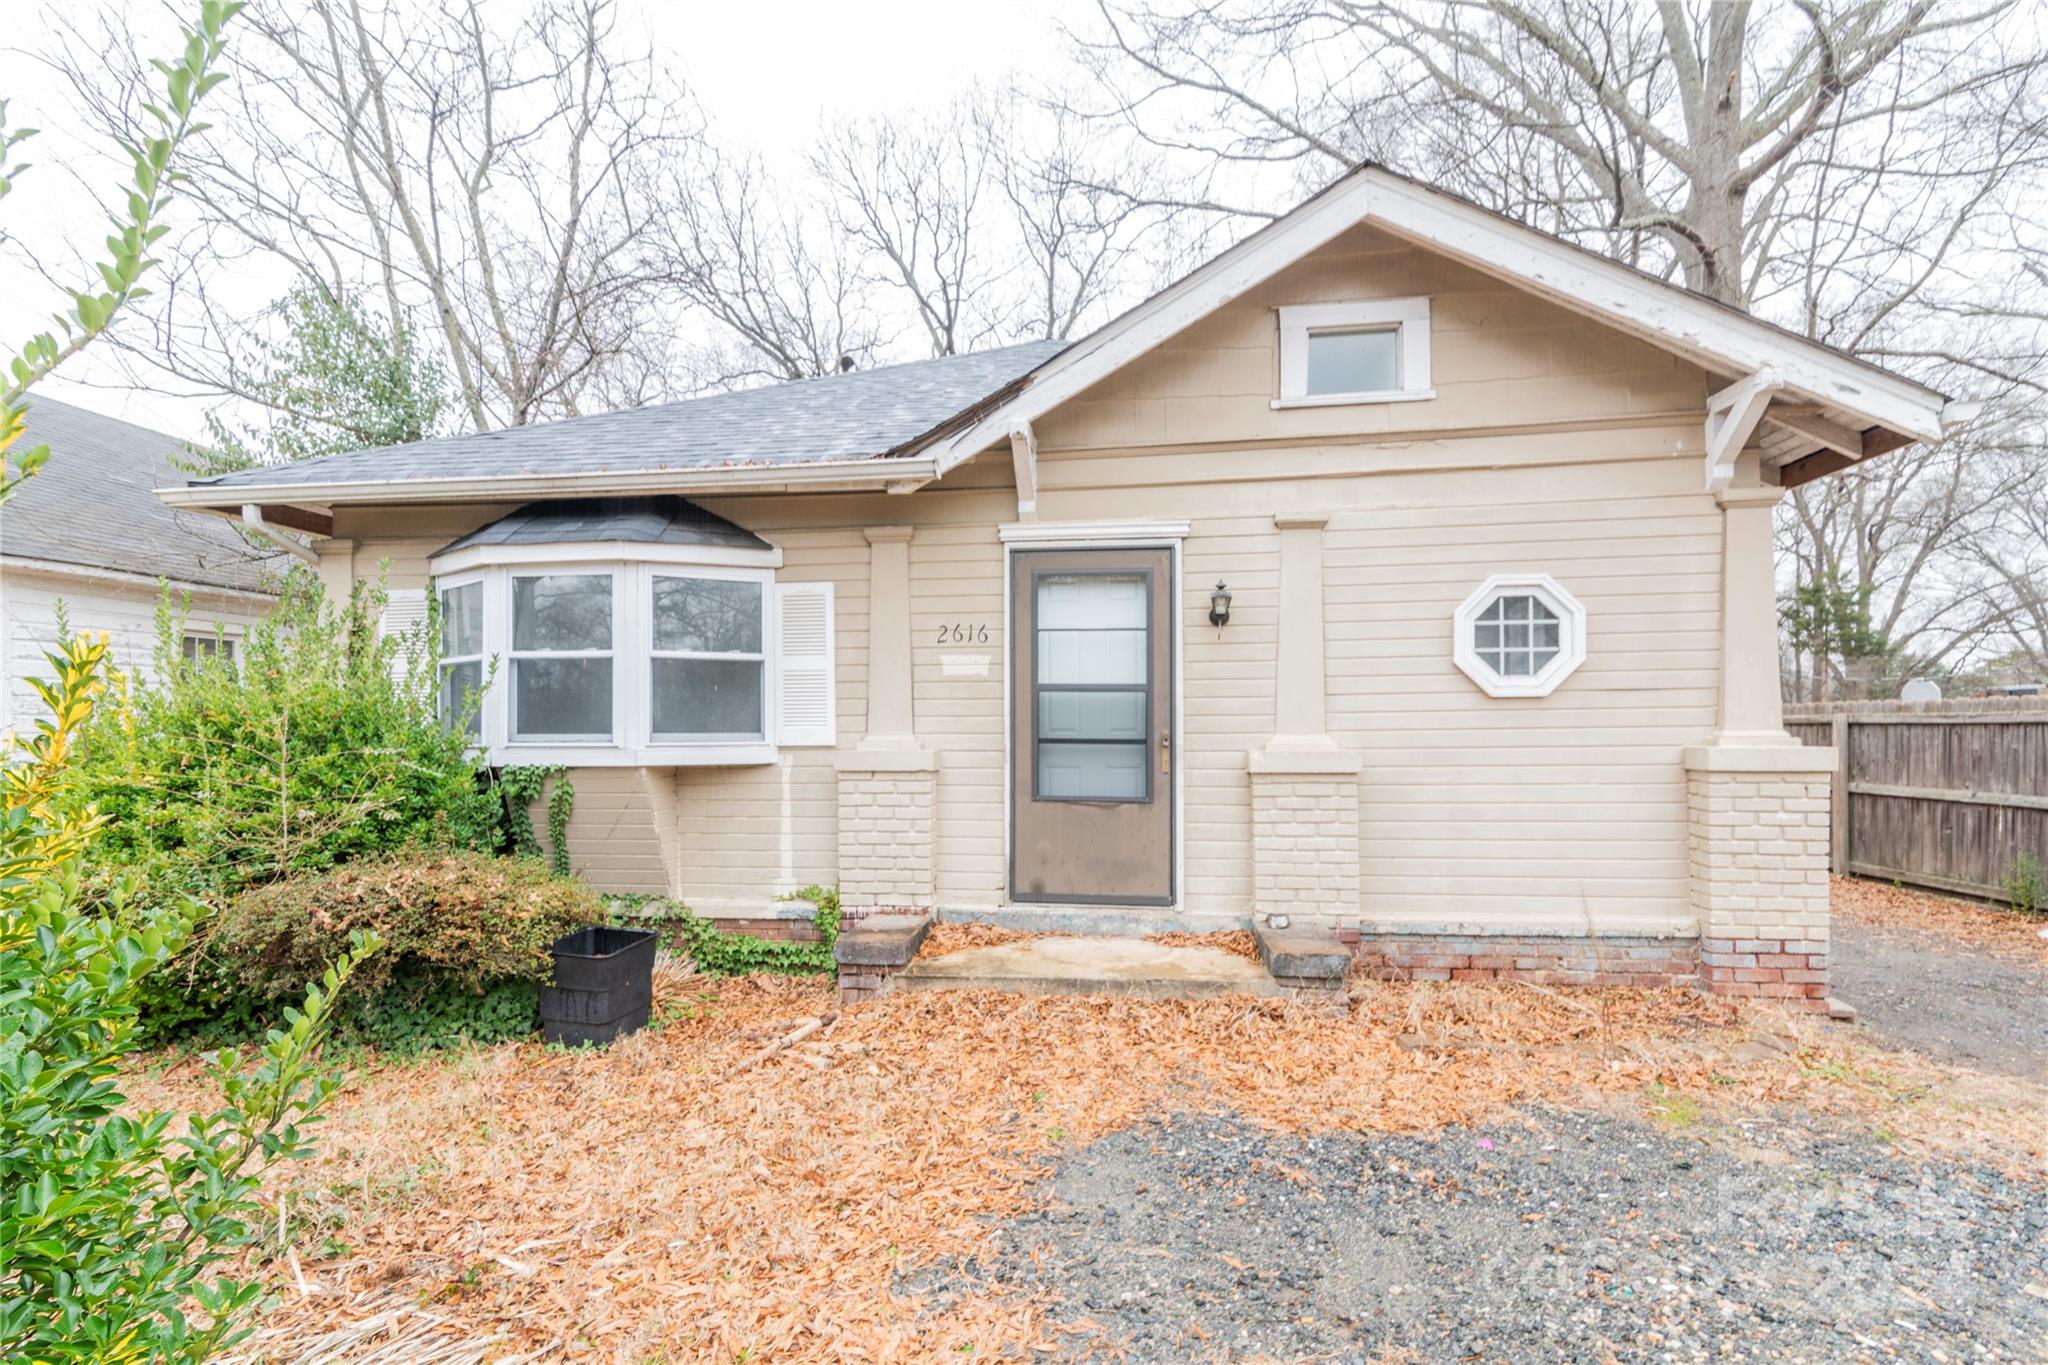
164,168 -> 1946,999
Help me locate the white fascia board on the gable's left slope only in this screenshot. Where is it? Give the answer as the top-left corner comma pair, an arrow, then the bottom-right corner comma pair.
938,172 -> 1368,475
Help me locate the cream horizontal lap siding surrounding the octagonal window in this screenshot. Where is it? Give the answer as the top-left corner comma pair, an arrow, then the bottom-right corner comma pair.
1325,485 -> 1720,927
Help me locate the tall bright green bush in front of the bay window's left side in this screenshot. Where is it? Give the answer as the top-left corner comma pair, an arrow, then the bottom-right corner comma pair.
76,569 -> 500,902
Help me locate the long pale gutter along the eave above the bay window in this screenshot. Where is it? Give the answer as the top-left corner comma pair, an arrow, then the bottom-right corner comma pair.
156,454 -> 938,512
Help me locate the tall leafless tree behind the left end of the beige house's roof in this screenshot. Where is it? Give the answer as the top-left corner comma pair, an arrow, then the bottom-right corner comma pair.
68,0 -> 694,430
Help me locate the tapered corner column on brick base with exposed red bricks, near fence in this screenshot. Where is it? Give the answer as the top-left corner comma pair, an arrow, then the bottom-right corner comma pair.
1683,474 -> 1835,1009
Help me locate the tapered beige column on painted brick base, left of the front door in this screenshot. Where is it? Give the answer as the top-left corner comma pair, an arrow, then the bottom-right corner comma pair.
834,526 -> 938,917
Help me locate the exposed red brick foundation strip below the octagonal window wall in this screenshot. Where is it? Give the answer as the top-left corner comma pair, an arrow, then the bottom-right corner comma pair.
1337,929 -> 1700,986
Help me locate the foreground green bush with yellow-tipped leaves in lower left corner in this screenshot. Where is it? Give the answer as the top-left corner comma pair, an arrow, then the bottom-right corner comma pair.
0,641 -> 377,1363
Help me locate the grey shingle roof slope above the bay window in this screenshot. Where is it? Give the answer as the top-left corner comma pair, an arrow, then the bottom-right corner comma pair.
197,342 -> 1065,497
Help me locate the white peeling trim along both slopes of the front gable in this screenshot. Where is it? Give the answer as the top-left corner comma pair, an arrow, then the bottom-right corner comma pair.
932,164 -> 1948,485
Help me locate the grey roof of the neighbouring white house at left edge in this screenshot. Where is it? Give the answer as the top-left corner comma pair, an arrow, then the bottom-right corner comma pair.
0,395 -> 281,591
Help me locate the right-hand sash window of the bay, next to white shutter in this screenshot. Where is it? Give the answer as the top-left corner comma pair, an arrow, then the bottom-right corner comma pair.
647,573 -> 768,743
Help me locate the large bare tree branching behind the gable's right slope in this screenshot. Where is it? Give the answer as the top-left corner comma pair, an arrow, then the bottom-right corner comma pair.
1081,0 -> 2048,687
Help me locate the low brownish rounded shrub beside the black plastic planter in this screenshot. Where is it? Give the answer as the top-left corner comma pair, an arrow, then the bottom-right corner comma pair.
205,853 -> 604,1001
